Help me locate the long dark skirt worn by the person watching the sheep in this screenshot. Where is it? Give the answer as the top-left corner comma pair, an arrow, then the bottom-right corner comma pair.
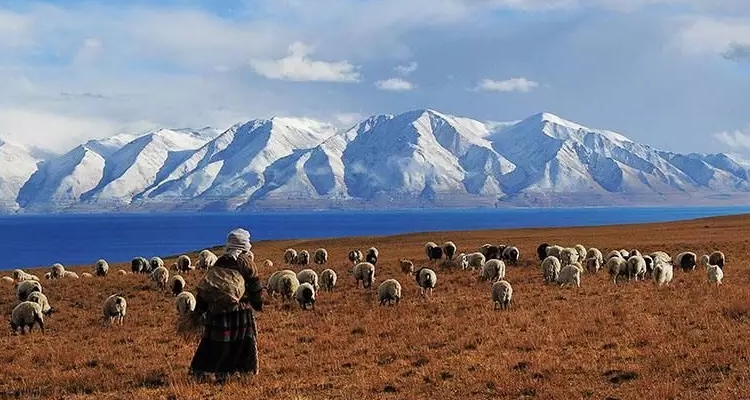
190,309 -> 258,374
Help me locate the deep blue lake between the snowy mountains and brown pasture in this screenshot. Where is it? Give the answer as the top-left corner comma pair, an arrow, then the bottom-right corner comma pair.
0,207 -> 750,270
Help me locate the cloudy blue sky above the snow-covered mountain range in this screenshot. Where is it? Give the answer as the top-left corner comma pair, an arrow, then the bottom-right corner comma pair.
0,0 -> 750,155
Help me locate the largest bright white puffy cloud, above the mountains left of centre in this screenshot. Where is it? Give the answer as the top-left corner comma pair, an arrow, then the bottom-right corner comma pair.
250,42 -> 360,82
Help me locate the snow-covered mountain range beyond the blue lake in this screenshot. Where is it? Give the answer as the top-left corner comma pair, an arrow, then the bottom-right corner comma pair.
0,109 -> 750,210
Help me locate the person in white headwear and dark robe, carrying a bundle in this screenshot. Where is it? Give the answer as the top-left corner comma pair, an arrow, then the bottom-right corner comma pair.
190,228 -> 263,383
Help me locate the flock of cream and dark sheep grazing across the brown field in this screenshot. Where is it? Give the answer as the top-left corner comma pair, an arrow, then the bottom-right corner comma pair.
1,241 -> 726,334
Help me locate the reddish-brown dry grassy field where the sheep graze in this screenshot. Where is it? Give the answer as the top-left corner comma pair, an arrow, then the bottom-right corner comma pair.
0,216 -> 750,400
